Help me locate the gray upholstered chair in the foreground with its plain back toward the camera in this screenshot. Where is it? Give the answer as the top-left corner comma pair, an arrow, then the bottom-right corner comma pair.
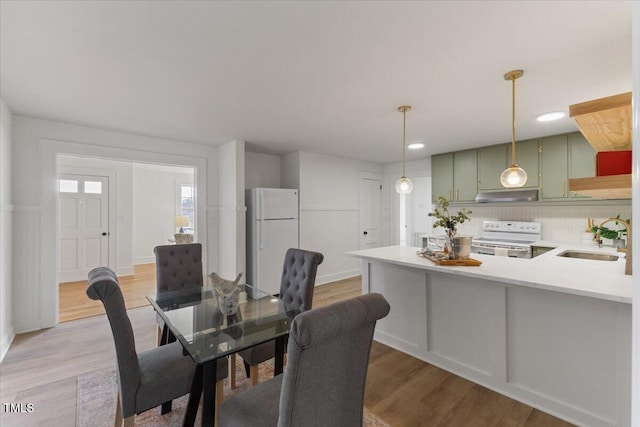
218,293 -> 389,427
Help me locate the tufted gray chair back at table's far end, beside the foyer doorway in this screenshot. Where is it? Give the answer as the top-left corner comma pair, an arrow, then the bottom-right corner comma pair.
153,243 -> 204,293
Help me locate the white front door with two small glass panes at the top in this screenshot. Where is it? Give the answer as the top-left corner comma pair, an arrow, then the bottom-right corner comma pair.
58,174 -> 109,283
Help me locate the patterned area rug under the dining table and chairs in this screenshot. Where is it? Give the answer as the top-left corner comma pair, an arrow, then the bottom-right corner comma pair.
76,357 -> 389,427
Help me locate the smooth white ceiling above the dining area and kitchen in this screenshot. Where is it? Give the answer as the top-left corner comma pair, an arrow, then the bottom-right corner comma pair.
0,0 -> 632,163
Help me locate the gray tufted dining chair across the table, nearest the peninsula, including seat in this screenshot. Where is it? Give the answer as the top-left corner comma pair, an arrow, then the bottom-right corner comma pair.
230,248 -> 324,388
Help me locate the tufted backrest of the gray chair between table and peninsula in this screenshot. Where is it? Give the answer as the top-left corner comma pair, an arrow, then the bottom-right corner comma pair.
280,248 -> 324,311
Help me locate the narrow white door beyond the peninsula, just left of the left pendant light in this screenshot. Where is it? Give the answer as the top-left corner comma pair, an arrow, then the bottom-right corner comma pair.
358,177 -> 382,249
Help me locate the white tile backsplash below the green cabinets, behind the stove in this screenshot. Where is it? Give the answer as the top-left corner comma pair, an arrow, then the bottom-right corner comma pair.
450,202 -> 631,242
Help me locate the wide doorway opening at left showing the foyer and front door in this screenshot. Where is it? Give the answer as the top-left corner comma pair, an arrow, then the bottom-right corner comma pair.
57,155 -> 197,322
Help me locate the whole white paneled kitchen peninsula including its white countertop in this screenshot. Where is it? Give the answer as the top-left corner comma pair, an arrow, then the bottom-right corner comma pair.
347,243 -> 631,426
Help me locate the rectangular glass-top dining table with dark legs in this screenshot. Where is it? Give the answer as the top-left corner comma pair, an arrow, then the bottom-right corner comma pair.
147,285 -> 298,426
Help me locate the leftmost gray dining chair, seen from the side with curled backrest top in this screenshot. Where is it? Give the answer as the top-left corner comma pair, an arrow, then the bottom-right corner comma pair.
87,267 -> 228,427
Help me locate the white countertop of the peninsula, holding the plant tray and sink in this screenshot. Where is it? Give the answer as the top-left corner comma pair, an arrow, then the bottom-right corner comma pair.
346,241 -> 631,304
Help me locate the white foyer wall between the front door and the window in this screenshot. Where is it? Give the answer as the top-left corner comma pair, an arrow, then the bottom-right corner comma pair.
132,163 -> 193,265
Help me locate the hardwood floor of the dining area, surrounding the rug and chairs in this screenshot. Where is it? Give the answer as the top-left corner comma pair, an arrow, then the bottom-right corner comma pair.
0,278 -> 570,427
